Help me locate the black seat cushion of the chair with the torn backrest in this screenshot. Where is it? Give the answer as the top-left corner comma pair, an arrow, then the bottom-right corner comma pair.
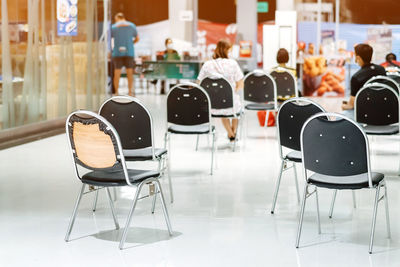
82,169 -> 160,186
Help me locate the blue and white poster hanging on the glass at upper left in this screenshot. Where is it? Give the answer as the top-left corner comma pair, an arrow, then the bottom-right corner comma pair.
57,0 -> 78,36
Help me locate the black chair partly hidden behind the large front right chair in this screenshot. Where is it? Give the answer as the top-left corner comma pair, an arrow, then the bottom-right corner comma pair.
271,98 -> 325,214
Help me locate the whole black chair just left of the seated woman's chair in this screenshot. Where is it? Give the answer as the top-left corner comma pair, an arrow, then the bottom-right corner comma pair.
165,83 -> 217,175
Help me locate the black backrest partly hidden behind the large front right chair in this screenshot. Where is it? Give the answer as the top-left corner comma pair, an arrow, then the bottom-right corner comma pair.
277,98 -> 325,157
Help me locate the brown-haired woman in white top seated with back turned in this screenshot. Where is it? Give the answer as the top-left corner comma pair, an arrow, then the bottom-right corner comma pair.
197,40 -> 243,141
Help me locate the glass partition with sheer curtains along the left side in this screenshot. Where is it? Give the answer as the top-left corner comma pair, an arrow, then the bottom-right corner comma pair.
0,0 -> 110,130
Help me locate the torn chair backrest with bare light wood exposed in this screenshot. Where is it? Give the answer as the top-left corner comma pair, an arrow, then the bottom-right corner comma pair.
66,110 -> 125,173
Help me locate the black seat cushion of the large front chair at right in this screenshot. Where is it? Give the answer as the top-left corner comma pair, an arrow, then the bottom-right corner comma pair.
308,172 -> 385,190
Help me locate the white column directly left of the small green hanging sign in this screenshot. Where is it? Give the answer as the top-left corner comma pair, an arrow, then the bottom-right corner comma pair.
236,0 -> 257,69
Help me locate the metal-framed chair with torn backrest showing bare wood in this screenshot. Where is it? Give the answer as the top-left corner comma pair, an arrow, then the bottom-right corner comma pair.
65,111 -> 172,249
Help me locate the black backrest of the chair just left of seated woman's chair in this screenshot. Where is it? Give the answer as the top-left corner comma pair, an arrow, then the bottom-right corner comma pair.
167,83 -> 211,129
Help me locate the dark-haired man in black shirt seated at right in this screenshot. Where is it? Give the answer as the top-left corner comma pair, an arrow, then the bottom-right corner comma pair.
342,44 -> 386,110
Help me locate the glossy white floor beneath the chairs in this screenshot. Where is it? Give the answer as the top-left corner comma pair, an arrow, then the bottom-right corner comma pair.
0,95 -> 400,267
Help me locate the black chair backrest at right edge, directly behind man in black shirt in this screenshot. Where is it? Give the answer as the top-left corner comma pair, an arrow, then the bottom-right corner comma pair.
354,83 -> 399,125
